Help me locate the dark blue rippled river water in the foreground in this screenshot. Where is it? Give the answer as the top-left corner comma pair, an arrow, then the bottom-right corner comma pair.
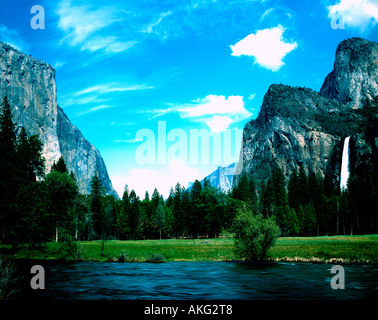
25,262 -> 378,300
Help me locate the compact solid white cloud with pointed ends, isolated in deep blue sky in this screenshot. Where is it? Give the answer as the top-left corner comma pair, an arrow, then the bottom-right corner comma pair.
230,25 -> 298,71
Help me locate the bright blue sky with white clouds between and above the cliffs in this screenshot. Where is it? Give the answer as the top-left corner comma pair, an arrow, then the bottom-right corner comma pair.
0,0 -> 378,199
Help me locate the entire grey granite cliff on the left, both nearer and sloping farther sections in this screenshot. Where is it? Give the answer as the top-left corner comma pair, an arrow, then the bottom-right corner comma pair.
0,42 -> 116,195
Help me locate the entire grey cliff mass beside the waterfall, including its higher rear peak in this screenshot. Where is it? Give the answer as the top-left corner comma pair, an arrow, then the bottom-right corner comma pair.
234,38 -> 378,183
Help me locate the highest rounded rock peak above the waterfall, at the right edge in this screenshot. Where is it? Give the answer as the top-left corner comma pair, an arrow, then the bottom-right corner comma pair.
320,38 -> 378,108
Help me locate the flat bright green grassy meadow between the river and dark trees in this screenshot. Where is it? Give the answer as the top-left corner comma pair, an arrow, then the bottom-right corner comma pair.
2,235 -> 378,264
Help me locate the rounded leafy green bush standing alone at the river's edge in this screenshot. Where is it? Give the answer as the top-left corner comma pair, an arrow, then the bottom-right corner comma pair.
234,206 -> 280,261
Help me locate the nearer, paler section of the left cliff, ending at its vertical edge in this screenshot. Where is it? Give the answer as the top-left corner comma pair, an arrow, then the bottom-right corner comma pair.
0,42 -> 60,168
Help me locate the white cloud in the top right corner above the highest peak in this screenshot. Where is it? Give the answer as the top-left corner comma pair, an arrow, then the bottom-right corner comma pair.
327,0 -> 378,32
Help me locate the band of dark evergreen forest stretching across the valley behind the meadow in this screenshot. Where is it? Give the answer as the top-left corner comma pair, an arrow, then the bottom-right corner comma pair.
0,97 -> 378,249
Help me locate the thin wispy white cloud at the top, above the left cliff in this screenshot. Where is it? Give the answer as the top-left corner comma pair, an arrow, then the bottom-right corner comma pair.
56,0 -> 136,53
